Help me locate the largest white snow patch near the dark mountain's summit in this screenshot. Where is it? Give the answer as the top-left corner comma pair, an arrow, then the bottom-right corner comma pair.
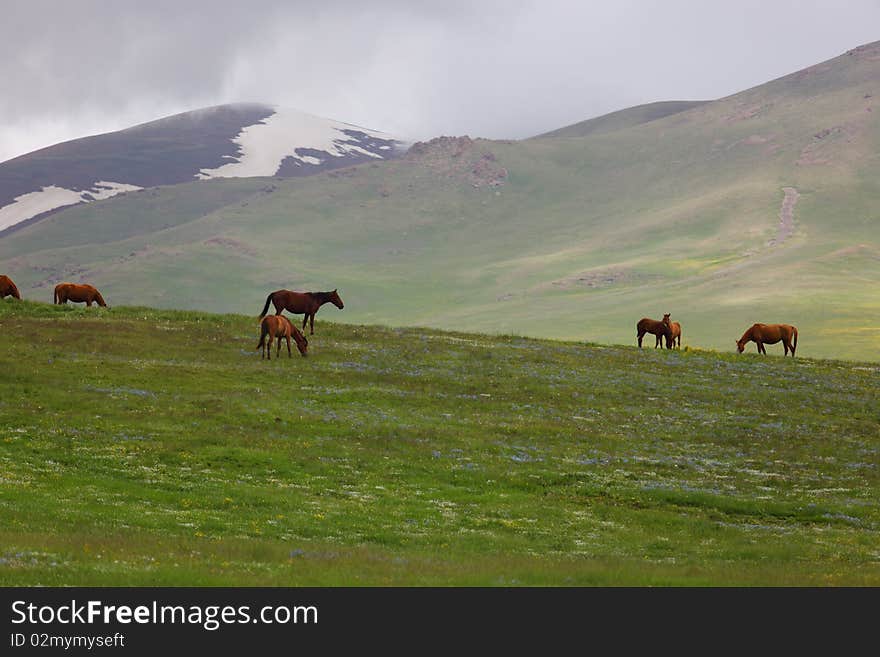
196,107 -> 394,180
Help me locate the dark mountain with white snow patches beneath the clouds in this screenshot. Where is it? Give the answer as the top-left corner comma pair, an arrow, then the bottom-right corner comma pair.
0,104 -> 405,235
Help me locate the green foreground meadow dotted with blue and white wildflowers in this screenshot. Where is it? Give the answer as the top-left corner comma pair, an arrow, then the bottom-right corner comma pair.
0,300 -> 880,586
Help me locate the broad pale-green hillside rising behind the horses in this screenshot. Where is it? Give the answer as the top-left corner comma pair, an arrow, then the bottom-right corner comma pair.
0,44 -> 880,360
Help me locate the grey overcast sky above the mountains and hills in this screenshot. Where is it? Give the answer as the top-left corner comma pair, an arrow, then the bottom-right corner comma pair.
0,0 -> 880,161
